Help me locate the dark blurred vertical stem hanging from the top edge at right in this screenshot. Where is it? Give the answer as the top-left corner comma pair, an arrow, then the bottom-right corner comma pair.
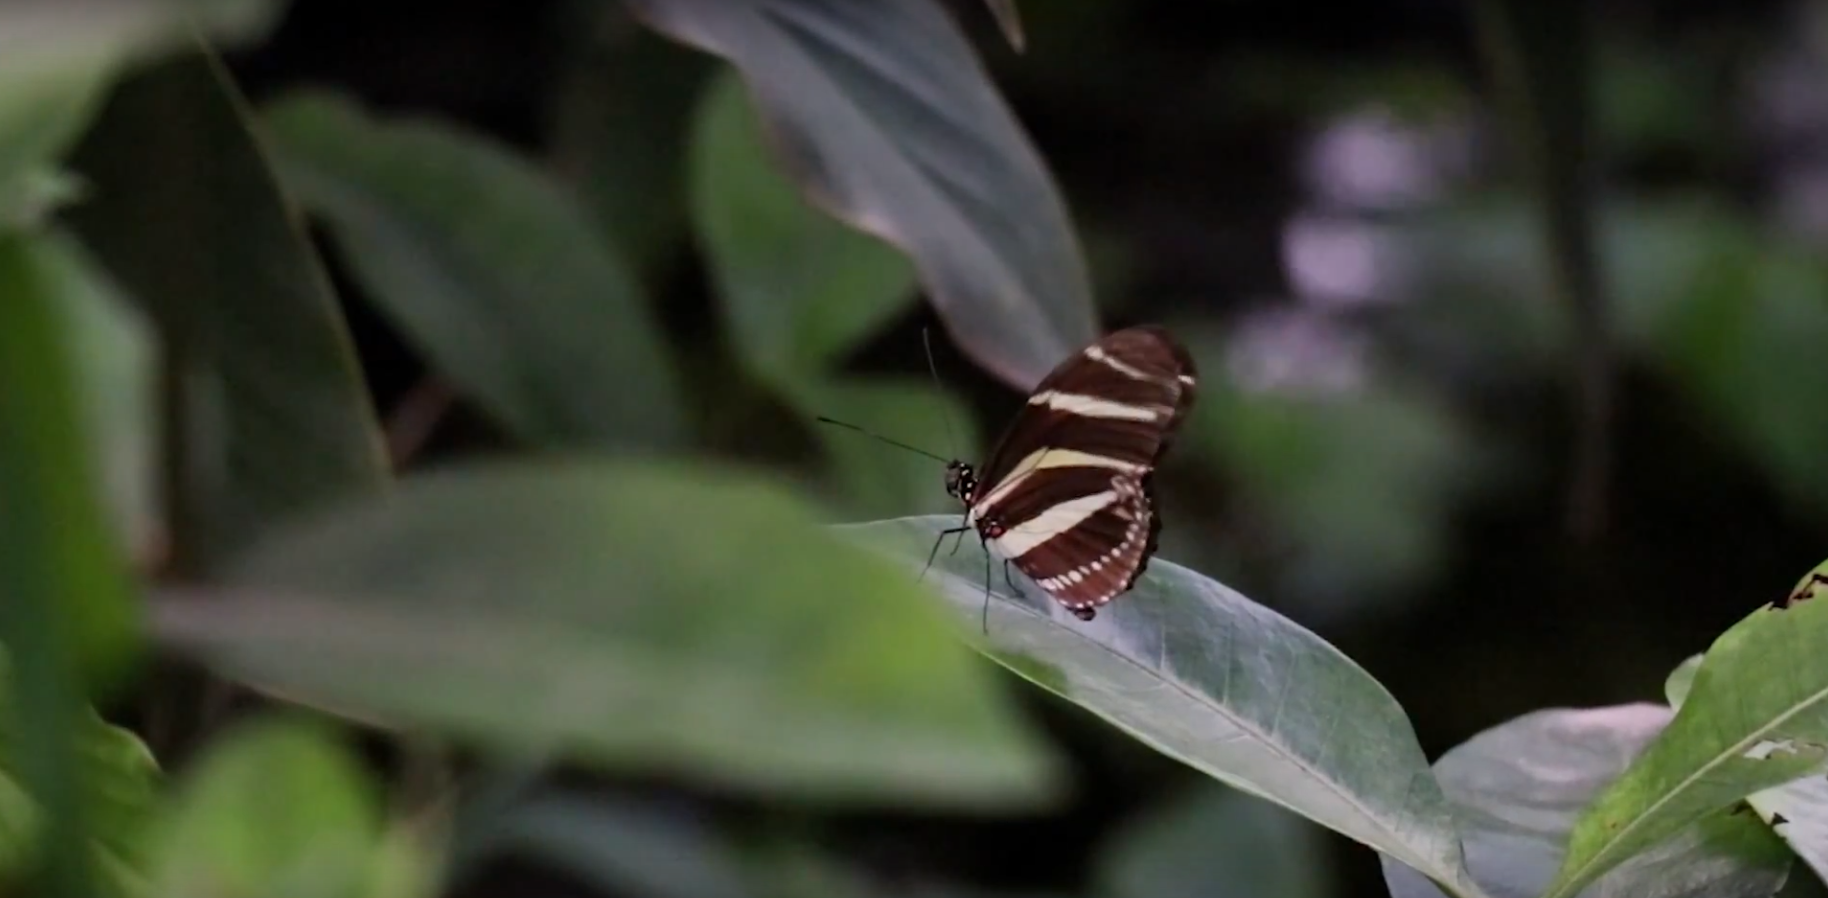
1473,0 -> 1614,543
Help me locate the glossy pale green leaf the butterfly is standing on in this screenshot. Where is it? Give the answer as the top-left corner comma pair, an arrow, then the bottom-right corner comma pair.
839,516 -> 1479,896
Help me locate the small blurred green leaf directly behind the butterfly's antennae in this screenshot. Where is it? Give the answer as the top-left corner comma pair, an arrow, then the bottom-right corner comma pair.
793,379 -> 978,519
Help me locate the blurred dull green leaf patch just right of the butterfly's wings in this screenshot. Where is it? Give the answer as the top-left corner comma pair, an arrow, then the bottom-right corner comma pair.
1186,327 -> 1499,615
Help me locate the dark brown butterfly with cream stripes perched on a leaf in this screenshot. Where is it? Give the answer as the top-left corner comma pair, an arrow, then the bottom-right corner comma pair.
934,326 -> 1196,620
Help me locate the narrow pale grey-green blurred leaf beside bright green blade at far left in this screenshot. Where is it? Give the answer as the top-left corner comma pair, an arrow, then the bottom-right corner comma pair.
38,232 -> 161,560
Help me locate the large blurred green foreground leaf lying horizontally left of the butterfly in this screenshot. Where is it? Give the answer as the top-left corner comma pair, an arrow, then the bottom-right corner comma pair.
157,461 -> 1057,807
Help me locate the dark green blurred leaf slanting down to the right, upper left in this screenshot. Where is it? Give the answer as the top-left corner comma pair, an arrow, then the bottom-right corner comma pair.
263,93 -> 684,446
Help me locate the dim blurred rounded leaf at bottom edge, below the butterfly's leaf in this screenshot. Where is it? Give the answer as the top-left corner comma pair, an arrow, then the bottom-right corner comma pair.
1099,785 -> 1333,898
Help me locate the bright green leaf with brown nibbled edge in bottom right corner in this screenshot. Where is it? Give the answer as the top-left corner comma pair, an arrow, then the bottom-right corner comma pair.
1546,565 -> 1828,898
